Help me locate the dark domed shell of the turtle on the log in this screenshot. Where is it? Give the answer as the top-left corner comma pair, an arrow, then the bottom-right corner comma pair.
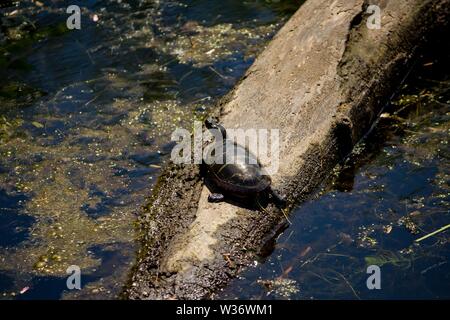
206,140 -> 271,194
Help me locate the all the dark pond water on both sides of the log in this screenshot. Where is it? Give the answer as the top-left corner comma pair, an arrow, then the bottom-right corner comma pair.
0,0 -> 450,299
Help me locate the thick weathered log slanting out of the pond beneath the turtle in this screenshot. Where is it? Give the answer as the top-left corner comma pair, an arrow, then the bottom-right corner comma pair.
126,0 -> 450,299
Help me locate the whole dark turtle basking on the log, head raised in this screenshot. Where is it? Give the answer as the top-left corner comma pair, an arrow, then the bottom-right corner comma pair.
203,117 -> 286,207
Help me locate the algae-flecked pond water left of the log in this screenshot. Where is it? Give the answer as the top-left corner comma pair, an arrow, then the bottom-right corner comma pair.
0,0 -> 301,299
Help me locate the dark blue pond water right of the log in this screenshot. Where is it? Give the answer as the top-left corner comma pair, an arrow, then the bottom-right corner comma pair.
219,39 -> 450,299
